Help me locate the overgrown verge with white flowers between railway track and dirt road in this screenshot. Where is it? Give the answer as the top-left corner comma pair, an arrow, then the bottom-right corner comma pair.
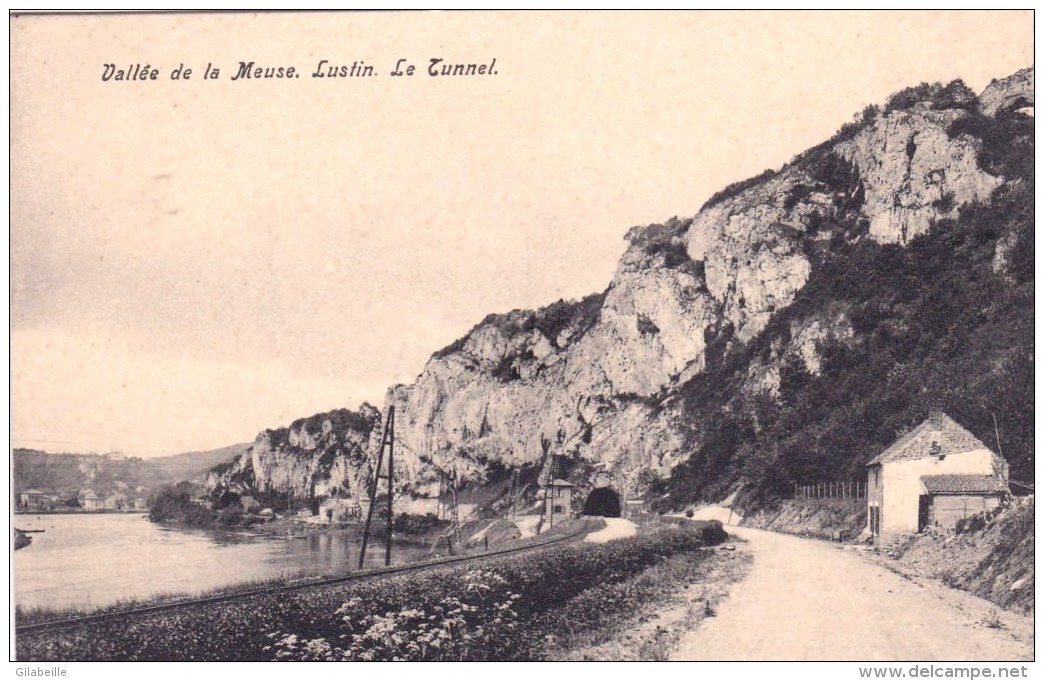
16,521 -> 712,661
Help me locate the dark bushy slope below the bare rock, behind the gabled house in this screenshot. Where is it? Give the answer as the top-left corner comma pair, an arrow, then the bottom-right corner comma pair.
654,98 -> 1034,510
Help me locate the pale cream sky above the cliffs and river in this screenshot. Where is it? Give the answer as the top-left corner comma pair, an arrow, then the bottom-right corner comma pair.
10,11 -> 1033,455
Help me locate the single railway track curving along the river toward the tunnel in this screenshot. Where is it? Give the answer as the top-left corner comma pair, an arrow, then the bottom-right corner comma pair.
15,520 -> 590,638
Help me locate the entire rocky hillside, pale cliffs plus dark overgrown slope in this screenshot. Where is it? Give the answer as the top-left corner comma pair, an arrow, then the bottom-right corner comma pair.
207,69 -> 1034,515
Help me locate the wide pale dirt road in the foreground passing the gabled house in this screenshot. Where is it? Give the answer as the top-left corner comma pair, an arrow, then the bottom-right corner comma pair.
671,527 -> 1033,661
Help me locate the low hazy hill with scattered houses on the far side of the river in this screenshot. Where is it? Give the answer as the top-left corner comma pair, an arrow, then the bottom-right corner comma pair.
11,444 -> 248,497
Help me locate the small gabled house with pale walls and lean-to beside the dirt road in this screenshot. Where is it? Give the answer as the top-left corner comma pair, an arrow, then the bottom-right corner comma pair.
867,412 -> 1011,544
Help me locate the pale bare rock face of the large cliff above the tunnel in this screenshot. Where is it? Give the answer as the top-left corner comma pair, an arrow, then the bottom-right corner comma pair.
387,71 -> 1033,505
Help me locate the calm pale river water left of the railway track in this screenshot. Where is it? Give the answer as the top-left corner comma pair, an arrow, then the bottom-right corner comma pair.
14,513 -> 426,609
